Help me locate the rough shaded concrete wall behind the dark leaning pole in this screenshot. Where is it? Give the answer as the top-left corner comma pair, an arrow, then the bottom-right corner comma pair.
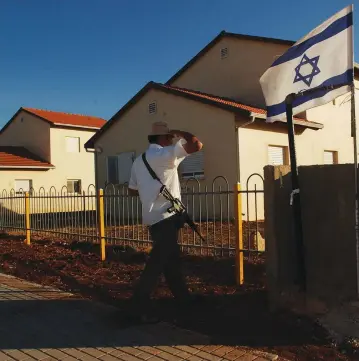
265,164 -> 357,304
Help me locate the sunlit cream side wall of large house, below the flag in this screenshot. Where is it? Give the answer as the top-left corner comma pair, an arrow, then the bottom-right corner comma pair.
237,89 -> 353,219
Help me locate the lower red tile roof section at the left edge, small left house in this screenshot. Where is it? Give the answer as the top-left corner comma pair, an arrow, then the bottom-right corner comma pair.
0,146 -> 54,168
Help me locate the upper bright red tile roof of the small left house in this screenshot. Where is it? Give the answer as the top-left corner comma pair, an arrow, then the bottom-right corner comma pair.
22,108 -> 106,129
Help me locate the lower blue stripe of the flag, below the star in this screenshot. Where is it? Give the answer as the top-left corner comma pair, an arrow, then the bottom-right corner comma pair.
267,69 -> 354,117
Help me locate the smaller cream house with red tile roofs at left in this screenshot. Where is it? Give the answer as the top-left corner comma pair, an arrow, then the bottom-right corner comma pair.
0,108 -> 105,194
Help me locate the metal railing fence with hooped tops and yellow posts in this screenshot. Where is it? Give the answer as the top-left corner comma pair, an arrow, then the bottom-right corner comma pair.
0,174 -> 264,283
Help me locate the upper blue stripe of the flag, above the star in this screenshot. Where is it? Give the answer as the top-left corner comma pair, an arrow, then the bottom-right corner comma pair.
272,12 -> 353,67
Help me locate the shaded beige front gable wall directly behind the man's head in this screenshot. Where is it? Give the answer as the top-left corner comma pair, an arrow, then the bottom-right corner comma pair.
95,90 -> 236,187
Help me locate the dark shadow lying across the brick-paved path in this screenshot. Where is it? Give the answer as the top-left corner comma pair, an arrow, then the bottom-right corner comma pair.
0,290 -> 208,349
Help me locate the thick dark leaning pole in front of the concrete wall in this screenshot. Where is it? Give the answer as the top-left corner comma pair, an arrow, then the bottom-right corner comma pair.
285,94 -> 306,291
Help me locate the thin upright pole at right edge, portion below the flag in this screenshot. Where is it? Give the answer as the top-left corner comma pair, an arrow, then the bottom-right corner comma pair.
351,82 -> 359,297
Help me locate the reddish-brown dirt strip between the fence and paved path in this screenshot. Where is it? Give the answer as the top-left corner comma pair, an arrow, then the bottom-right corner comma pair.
0,235 -> 359,361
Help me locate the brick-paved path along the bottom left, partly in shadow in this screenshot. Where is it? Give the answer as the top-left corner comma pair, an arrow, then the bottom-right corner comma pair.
0,274 -> 277,361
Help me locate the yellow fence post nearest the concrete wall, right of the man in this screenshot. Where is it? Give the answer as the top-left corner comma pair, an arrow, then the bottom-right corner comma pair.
234,183 -> 244,285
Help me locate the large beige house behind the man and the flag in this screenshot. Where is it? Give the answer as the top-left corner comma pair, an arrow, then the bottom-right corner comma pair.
85,32 -> 359,217
